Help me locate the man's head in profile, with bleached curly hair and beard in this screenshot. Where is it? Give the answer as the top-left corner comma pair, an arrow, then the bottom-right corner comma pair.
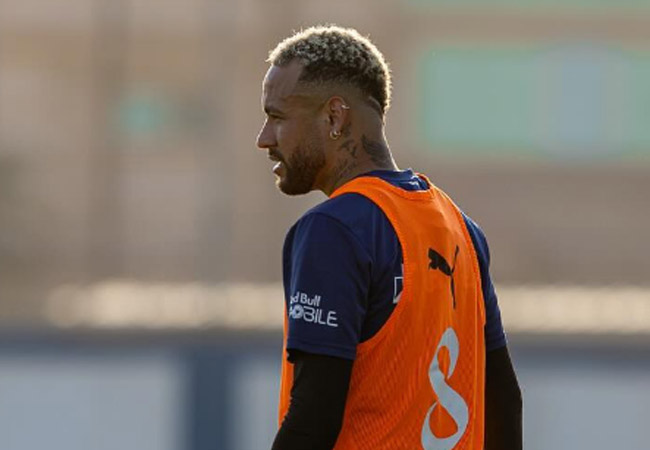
257,26 -> 390,195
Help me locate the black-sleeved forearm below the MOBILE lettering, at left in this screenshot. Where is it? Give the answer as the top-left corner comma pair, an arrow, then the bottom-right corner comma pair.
272,350 -> 353,450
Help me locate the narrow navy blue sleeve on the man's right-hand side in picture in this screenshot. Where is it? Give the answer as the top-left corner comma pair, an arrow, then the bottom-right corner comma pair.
463,214 -> 506,351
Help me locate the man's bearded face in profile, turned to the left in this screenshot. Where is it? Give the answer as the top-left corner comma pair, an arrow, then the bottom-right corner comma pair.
257,62 -> 326,195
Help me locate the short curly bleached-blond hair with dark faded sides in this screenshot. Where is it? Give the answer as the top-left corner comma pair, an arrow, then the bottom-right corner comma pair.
267,25 -> 391,115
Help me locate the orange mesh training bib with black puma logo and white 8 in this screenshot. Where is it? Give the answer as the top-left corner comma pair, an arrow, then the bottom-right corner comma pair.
279,177 -> 485,450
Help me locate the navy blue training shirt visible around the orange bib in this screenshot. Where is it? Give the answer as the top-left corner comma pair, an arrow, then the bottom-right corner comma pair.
283,170 -> 506,359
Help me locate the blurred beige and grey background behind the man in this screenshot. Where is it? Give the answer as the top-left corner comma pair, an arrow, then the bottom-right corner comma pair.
0,0 -> 650,450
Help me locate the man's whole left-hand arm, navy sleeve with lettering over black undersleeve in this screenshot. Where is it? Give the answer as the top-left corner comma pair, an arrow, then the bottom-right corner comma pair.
272,212 -> 372,450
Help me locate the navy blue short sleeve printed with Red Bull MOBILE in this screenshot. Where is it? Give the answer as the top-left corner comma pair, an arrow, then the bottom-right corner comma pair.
284,213 -> 371,359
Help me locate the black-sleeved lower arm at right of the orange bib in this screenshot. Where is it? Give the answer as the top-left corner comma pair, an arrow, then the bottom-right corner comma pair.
485,347 -> 523,450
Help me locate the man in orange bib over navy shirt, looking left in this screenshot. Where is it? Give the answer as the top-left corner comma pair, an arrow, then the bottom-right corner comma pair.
257,26 -> 522,450
